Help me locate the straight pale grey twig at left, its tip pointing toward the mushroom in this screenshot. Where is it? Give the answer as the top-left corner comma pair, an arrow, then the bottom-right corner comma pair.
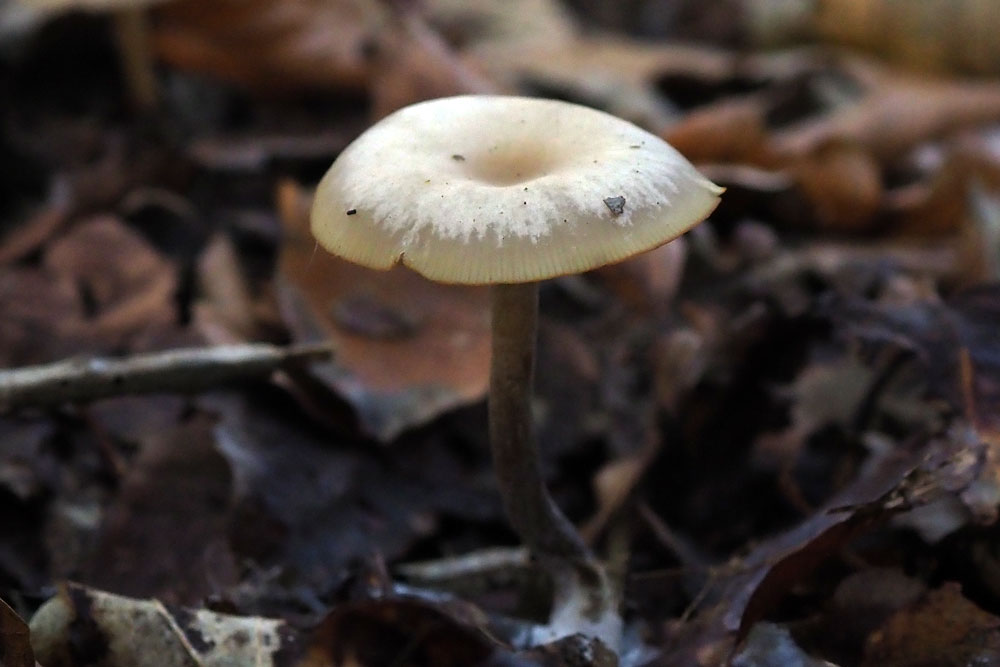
0,343 -> 332,412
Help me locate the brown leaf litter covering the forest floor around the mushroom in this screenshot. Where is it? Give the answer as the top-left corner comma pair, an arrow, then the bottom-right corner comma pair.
0,0 -> 1000,667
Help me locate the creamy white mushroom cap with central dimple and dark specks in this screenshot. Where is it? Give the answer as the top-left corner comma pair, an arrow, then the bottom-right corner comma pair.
312,95 -> 722,284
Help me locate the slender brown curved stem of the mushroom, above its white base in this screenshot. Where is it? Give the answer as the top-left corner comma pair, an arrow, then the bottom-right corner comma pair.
489,283 -> 593,564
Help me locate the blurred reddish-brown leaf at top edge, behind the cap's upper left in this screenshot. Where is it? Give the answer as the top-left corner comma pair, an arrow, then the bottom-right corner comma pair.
155,0 -> 497,112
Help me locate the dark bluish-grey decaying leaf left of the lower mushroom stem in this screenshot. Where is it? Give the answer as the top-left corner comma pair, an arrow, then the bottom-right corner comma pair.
204,397 -> 500,592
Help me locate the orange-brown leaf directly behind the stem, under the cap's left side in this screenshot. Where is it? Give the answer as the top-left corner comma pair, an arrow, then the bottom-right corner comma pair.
279,182 -> 490,441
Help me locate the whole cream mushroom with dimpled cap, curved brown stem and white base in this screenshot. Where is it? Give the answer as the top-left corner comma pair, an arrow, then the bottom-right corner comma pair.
312,95 -> 722,646
